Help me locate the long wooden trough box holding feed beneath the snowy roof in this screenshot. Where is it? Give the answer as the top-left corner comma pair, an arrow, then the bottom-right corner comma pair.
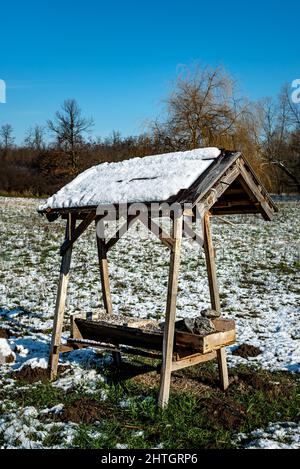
64,314 -> 235,362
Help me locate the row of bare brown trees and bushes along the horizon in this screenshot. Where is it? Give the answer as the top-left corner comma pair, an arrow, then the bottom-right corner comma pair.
0,65 -> 300,196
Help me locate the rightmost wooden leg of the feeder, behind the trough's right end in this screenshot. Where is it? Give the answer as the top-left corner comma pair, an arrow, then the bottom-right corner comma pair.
203,212 -> 229,391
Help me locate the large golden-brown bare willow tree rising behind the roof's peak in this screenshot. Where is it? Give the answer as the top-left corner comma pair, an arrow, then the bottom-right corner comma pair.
153,66 -> 244,149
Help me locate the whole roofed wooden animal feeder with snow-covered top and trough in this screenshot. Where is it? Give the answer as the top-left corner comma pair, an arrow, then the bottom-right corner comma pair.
40,149 -> 277,407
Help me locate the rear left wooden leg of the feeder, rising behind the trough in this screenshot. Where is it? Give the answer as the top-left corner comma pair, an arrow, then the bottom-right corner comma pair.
96,221 -> 122,366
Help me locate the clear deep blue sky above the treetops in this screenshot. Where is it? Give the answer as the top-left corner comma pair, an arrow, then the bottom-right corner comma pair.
0,0 -> 300,142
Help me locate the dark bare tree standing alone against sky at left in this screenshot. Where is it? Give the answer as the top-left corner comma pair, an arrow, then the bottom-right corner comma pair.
48,99 -> 93,173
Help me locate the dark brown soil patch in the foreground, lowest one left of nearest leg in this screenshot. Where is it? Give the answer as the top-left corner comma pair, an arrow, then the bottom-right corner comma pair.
55,397 -> 112,424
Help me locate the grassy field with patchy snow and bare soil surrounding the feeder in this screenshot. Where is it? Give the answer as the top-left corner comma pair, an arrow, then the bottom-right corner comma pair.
0,198 -> 300,448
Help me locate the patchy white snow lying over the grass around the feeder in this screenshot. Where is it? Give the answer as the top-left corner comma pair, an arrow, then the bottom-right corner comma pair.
0,198 -> 300,447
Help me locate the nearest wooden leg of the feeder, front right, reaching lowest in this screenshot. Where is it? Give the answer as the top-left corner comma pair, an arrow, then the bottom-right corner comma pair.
158,215 -> 183,408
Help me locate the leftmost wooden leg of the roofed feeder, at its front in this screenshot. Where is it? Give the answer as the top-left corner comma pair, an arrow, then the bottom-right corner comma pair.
49,215 -> 76,380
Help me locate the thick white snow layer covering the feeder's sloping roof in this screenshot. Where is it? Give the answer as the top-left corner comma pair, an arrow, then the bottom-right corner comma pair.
40,147 -> 221,210
